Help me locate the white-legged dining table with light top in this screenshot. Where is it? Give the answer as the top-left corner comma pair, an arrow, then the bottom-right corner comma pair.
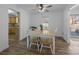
27,30 -> 55,54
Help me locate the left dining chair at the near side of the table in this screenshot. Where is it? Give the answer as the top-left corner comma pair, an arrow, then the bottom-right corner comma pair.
29,30 -> 40,51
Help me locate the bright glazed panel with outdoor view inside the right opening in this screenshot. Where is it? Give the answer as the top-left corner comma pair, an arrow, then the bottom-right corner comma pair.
70,14 -> 79,38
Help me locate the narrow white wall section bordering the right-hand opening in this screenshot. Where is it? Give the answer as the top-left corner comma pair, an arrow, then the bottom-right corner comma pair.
62,5 -> 73,43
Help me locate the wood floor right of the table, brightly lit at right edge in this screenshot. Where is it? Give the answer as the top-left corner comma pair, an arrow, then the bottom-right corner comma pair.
55,39 -> 79,55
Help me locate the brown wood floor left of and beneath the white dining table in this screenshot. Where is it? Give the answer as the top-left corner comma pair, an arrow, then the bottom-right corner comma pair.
0,39 -> 51,55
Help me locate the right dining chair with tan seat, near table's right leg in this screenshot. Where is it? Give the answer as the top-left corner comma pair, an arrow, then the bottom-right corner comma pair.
40,35 -> 53,54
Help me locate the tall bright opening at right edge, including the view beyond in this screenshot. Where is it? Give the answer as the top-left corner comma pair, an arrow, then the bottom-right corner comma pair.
69,5 -> 79,49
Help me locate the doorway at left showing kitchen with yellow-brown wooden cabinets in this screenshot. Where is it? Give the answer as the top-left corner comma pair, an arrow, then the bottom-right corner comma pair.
8,8 -> 20,46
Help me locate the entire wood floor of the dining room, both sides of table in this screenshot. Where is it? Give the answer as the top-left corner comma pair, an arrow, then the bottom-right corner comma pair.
0,38 -> 79,55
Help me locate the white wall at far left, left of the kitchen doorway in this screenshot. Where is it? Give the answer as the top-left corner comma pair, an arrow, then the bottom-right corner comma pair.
0,5 -> 8,51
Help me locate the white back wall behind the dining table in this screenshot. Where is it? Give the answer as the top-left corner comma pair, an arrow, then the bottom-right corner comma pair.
29,11 -> 63,36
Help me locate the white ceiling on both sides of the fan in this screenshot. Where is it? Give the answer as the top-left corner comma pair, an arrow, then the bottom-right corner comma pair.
17,4 -> 68,11
